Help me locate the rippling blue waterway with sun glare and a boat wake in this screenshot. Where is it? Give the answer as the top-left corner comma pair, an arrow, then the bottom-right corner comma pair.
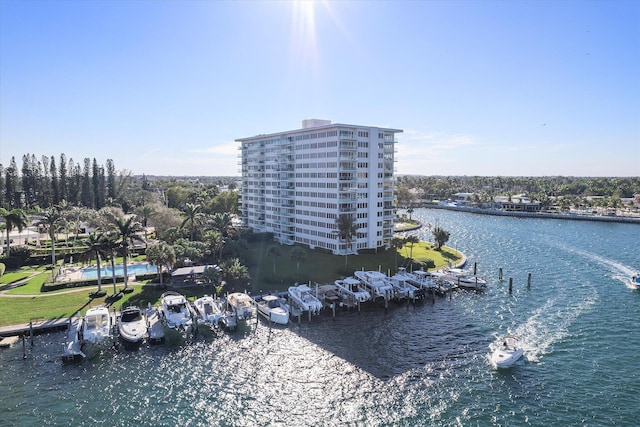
0,210 -> 640,426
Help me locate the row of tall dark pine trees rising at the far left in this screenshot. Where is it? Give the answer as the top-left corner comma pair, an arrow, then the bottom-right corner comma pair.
0,154 -> 117,210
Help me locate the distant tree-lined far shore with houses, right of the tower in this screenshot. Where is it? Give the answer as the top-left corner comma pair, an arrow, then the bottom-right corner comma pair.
396,175 -> 640,207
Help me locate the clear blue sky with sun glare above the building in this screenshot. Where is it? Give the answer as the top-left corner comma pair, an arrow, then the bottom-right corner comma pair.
0,0 -> 640,176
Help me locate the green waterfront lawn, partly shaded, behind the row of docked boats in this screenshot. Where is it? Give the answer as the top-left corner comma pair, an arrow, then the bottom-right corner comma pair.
0,241 -> 460,326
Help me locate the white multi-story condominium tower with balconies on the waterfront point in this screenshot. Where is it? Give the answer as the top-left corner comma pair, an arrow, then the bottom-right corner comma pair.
236,119 -> 402,254
